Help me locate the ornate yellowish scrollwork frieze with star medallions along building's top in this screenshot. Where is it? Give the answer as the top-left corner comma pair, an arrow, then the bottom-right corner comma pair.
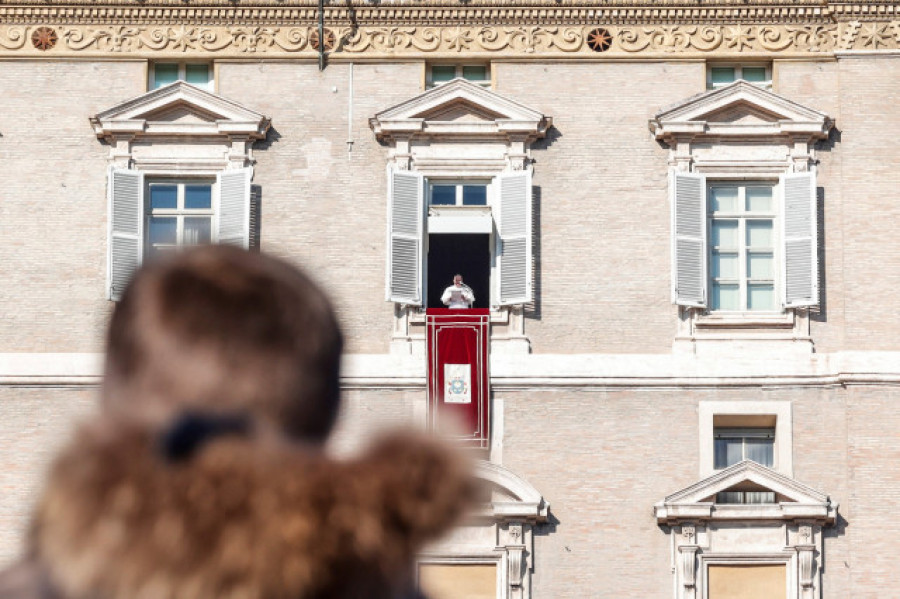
0,20 -> 900,61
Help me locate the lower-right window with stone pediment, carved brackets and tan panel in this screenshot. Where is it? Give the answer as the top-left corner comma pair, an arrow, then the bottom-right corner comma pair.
655,460 -> 837,599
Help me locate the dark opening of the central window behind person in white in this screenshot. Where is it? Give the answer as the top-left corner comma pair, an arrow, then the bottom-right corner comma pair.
427,233 -> 491,308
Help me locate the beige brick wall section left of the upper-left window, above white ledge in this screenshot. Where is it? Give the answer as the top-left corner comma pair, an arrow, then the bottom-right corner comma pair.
0,60 -> 146,352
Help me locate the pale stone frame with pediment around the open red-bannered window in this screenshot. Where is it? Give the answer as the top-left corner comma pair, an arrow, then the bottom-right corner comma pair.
369,79 -> 552,355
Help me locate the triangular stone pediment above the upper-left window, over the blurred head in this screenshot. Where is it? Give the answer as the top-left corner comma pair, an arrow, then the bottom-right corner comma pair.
91,81 -> 269,140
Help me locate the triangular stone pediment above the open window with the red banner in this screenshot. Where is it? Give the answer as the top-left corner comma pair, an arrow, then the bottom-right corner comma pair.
369,79 -> 552,140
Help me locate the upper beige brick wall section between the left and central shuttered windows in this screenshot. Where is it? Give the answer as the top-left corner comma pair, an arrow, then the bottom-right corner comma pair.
219,63 -> 423,353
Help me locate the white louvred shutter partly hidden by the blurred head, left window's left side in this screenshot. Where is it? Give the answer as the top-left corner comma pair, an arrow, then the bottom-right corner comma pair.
107,169 -> 144,301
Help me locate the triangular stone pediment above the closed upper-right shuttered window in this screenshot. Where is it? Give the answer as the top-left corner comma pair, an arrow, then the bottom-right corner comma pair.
650,81 -> 833,141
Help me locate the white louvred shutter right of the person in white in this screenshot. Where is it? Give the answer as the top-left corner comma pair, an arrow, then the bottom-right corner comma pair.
494,170 -> 531,306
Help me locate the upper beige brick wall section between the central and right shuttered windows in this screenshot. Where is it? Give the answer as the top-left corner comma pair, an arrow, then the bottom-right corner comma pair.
494,62 -> 704,353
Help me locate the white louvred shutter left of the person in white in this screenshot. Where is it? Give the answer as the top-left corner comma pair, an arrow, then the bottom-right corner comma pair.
386,170 -> 425,306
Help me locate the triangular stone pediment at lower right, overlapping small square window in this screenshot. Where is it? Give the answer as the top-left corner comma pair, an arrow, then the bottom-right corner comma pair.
655,461 -> 837,525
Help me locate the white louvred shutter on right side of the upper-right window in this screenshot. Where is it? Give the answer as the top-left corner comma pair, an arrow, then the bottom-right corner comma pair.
781,171 -> 819,308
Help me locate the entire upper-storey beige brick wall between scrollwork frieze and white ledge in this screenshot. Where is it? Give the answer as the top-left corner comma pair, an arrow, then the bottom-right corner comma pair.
0,58 -> 900,353
